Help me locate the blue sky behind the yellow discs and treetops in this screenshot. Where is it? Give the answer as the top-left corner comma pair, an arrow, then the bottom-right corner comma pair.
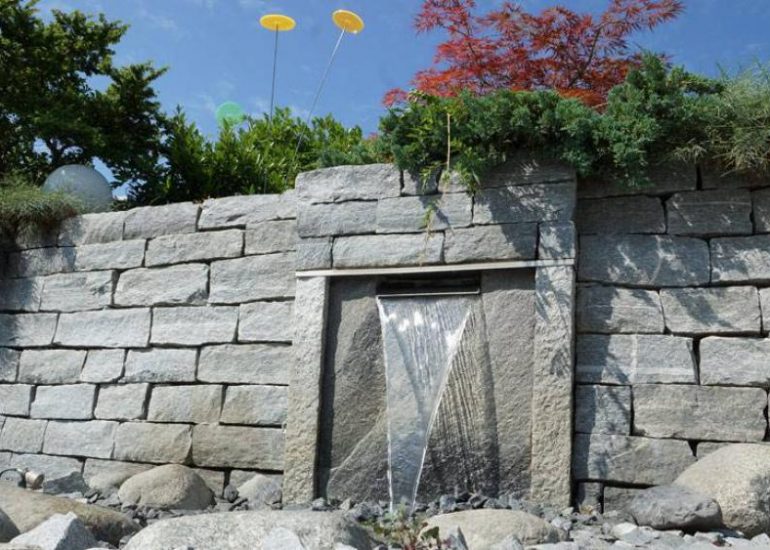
34,0 -> 770,135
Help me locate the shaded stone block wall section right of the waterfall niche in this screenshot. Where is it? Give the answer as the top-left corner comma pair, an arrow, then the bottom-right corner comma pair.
573,167 -> 770,509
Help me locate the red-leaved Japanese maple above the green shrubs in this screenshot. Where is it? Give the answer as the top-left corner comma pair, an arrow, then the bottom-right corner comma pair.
384,0 -> 683,105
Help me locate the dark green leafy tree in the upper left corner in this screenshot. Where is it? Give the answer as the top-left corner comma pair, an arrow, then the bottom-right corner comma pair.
0,0 -> 164,183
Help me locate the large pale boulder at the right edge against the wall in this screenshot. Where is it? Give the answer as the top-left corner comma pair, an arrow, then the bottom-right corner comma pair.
674,444 -> 770,537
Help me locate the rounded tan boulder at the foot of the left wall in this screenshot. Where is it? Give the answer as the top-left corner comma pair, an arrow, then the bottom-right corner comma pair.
118,464 -> 214,510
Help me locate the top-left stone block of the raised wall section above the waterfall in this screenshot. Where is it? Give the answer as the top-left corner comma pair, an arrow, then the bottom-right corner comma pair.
295,164 -> 401,207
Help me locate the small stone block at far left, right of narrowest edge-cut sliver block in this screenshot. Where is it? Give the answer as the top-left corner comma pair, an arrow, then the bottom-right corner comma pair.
19,349 -> 86,384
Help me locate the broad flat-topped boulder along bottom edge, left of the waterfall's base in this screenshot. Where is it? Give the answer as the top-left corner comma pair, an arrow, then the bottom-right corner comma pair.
124,511 -> 372,550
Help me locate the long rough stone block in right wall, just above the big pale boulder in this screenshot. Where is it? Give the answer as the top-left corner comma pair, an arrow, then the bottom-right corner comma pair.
634,384 -> 767,441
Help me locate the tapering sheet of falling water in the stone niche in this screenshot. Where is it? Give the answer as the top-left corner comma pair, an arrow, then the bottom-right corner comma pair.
377,295 -> 473,511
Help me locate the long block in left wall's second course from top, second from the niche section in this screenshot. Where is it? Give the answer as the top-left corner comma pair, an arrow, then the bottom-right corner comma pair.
144,229 -> 243,266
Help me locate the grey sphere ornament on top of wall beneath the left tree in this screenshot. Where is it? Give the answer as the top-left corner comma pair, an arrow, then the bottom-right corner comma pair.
43,164 -> 112,212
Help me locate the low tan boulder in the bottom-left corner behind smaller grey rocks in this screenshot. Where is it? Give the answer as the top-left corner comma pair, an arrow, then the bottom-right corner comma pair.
0,483 -> 139,545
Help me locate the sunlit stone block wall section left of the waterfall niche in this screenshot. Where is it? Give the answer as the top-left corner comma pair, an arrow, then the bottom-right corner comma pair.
0,193 -> 296,493
